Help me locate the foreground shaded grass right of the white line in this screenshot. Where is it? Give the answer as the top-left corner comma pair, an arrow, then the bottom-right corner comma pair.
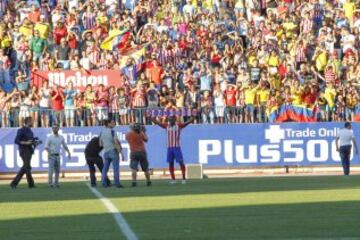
124,201 -> 360,239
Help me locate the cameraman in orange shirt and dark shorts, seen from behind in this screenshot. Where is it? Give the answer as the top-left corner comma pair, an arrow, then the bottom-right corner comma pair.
126,123 -> 151,187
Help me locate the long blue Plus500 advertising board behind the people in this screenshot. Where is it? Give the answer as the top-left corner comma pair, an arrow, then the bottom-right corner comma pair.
0,123 -> 360,172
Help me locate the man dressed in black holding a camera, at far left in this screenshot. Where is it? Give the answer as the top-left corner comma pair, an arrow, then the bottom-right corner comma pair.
10,117 -> 35,188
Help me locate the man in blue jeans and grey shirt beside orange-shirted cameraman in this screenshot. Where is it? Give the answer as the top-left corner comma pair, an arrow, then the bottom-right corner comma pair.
100,120 -> 124,188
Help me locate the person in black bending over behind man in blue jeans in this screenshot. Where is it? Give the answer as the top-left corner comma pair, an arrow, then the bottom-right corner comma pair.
85,137 -> 111,187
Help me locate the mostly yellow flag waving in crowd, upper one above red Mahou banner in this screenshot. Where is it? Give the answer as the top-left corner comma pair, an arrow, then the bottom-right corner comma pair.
100,30 -> 130,51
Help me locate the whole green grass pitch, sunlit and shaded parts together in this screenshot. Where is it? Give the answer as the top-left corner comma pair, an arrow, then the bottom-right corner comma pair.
0,176 -> 360,240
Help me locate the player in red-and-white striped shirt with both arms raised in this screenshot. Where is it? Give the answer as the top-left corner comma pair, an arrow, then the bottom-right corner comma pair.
152,117 -> 194,184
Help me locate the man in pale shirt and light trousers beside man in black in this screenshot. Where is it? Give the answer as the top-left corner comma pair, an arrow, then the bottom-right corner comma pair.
45,124 -> 71,188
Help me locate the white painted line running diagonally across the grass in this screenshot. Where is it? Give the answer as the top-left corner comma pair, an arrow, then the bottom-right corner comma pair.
86,183 -> 138,240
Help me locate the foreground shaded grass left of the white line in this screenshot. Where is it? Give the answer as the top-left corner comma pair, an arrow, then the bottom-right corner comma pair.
0,214 -> 124,240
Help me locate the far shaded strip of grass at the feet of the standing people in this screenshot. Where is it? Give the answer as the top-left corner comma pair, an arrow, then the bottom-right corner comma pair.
0,176 -> 360,203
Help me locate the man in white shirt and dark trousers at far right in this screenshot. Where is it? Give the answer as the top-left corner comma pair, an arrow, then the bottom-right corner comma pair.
336,122 -> 358,175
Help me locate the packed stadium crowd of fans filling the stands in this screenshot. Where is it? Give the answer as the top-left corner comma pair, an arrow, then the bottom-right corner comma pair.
0,0 -> 360,127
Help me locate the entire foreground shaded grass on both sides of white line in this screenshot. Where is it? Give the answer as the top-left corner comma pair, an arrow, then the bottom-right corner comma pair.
0,201 -> 360,240
